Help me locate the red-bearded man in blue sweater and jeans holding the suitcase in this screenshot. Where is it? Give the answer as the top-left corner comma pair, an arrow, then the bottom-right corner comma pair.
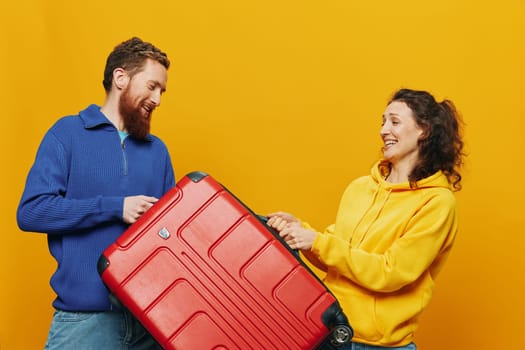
17,37 -> 175,350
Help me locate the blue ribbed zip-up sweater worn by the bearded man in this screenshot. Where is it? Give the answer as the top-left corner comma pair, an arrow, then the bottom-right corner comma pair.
17,105 -> 175,311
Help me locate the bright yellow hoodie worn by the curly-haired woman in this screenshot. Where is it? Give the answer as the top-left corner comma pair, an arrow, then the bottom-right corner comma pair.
303,163 -> 457,346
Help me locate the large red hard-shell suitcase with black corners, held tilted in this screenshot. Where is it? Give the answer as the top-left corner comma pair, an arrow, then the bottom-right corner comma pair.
98,172 -> 353,350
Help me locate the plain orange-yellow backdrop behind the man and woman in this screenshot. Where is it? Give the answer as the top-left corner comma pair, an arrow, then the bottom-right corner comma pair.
0,0 -> 525,350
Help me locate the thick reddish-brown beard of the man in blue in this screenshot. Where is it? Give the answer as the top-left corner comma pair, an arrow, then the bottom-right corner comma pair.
119,88 -> 151,140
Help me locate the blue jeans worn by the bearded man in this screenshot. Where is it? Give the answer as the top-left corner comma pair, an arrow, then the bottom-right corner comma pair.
45,310 -> 162,350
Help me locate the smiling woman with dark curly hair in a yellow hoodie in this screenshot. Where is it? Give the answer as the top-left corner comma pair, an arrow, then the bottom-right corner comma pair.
268,89 -> 463,350
